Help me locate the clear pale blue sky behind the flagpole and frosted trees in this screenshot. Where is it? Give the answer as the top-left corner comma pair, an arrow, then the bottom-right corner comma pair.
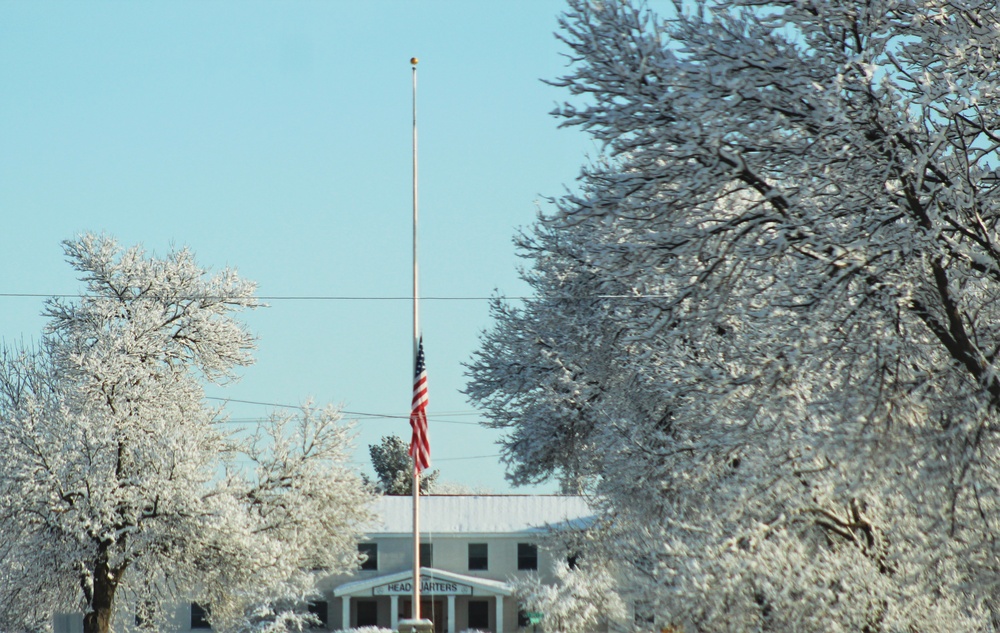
0,0 -> 594,491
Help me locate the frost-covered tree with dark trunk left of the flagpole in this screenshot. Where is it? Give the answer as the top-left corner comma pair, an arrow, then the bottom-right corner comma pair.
0,235 -> 369,633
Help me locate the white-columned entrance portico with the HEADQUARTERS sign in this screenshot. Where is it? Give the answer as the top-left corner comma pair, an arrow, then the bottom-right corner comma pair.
333,567 -> 512,633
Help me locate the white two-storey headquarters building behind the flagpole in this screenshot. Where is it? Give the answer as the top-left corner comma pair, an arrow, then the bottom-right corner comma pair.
318,495 -> 592,633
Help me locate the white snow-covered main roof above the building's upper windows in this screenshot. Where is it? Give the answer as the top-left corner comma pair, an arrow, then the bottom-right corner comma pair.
369,495 -> 594,535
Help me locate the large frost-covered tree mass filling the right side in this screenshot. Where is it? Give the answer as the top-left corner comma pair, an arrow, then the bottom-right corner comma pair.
468,0 -> 1000,632
